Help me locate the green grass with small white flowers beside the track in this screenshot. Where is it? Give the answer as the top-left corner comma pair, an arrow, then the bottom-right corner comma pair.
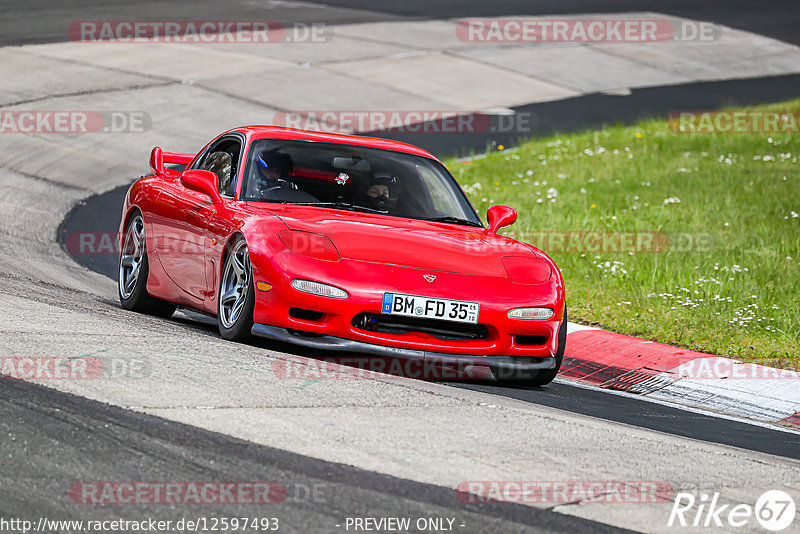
449,100 -> 800,368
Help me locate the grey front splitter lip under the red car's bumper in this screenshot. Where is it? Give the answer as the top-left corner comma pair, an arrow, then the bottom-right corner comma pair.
252,323 -> 556,380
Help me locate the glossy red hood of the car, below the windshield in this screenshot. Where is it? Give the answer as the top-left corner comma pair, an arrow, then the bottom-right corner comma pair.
250,205 -> 537,277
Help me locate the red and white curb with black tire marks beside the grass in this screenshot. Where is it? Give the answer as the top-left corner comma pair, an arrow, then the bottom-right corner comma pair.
558,323 -> 800,428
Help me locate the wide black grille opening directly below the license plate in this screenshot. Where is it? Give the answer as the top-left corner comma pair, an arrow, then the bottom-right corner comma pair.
353,313 -> 489,340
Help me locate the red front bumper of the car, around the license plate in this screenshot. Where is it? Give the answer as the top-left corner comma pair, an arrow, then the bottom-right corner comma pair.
251,251 -> 564,362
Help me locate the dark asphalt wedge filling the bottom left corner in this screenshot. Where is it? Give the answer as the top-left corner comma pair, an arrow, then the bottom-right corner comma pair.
0,379 -> 619,534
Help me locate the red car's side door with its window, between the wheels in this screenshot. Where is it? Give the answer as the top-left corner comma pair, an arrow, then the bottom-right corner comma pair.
154,137 -> 242,301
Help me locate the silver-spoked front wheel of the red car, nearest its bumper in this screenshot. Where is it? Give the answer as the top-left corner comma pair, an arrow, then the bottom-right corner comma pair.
217,237 -> 256,341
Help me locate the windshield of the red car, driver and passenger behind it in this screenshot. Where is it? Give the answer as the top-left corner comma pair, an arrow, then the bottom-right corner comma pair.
241,139 -> 481,226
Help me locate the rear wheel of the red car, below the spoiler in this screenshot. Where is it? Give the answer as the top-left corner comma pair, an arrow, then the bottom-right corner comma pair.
117,210 -> 177,318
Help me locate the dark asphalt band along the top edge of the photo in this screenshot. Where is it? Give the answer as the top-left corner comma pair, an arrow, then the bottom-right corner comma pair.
0,0 -> 800,45
